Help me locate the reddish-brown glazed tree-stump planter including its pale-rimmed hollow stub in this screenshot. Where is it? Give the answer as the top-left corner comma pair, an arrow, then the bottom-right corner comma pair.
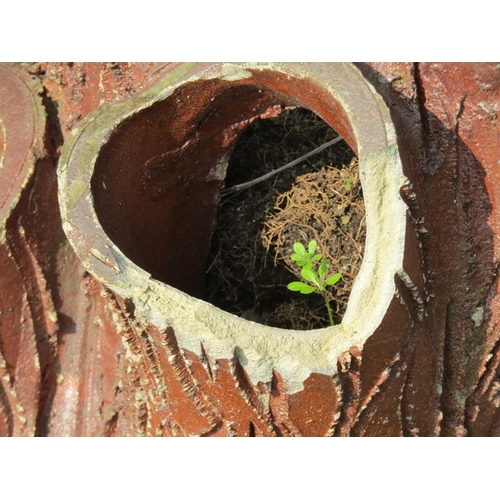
0,63 -> 500,436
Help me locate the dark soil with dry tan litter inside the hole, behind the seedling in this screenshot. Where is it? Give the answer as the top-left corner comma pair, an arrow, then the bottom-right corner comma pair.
206,109 -> 365,330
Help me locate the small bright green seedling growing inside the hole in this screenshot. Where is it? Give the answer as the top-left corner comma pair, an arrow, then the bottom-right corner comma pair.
287,240 -> 342,325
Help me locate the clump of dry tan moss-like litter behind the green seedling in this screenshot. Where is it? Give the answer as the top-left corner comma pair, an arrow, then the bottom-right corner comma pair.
261,160 -> 365,328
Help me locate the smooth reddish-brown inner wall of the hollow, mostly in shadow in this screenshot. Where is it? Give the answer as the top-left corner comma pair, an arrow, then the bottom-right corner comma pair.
91,70 -> 357,297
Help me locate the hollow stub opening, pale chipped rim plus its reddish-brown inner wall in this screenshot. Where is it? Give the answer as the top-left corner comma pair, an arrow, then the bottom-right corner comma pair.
59,63 -> 406,393
